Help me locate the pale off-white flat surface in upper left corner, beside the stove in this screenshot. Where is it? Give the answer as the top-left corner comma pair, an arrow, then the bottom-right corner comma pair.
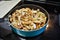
0,0 -> 21,18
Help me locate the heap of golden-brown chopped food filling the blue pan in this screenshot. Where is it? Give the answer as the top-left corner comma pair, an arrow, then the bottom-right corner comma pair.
9,8 -> 47,31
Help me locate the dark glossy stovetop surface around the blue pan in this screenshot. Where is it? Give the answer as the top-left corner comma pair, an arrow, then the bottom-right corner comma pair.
0,1 -> 60,40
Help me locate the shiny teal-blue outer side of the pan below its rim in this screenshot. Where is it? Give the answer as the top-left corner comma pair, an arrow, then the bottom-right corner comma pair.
11,24 -> 47,37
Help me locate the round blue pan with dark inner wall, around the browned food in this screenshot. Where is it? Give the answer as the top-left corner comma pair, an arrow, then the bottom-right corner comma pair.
8,4 -> 49,37
